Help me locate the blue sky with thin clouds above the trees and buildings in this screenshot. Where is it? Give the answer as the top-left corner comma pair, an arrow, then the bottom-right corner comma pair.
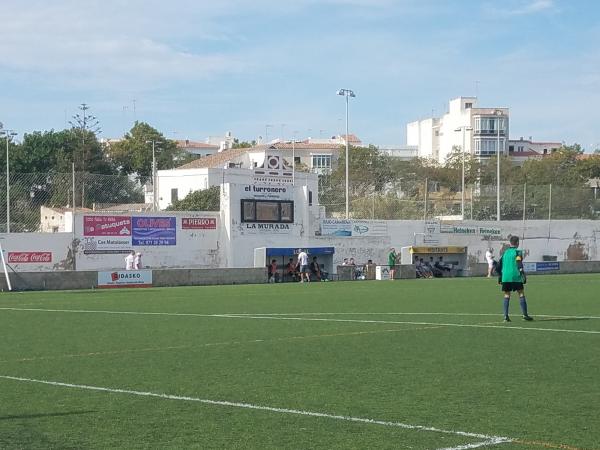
0,0 -> 600,149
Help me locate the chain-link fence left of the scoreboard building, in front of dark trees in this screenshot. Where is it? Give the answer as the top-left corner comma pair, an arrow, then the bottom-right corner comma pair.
0,172 -> 144,233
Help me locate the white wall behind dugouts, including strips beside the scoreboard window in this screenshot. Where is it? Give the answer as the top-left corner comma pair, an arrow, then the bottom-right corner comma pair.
0,219 -> 600,272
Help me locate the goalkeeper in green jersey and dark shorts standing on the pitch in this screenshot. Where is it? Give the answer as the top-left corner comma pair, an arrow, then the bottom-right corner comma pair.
496,236 -> 533,322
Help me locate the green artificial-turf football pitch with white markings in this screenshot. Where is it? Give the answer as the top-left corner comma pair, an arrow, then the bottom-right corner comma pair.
0,274 -> 600,450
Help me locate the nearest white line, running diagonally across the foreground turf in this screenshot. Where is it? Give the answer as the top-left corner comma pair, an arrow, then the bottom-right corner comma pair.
0,375 -> 513,449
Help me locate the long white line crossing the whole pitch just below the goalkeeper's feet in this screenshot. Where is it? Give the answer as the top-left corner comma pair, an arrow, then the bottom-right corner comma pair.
0,308 -> 600,334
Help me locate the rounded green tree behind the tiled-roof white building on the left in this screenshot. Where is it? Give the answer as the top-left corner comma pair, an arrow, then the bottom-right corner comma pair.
108,121 -> 195,183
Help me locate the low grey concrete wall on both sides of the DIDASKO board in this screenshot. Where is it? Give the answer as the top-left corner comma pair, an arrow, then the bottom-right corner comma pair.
0,267 -> 267,291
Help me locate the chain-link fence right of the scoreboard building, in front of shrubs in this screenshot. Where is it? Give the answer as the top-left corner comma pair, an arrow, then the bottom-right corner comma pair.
319,180 -> 600,220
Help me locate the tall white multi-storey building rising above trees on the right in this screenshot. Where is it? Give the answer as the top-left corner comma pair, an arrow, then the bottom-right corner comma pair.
406,97 -> 509,163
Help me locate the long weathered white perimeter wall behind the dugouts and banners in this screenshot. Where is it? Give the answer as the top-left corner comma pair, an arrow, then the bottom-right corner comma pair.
0,219 -> 600,273
